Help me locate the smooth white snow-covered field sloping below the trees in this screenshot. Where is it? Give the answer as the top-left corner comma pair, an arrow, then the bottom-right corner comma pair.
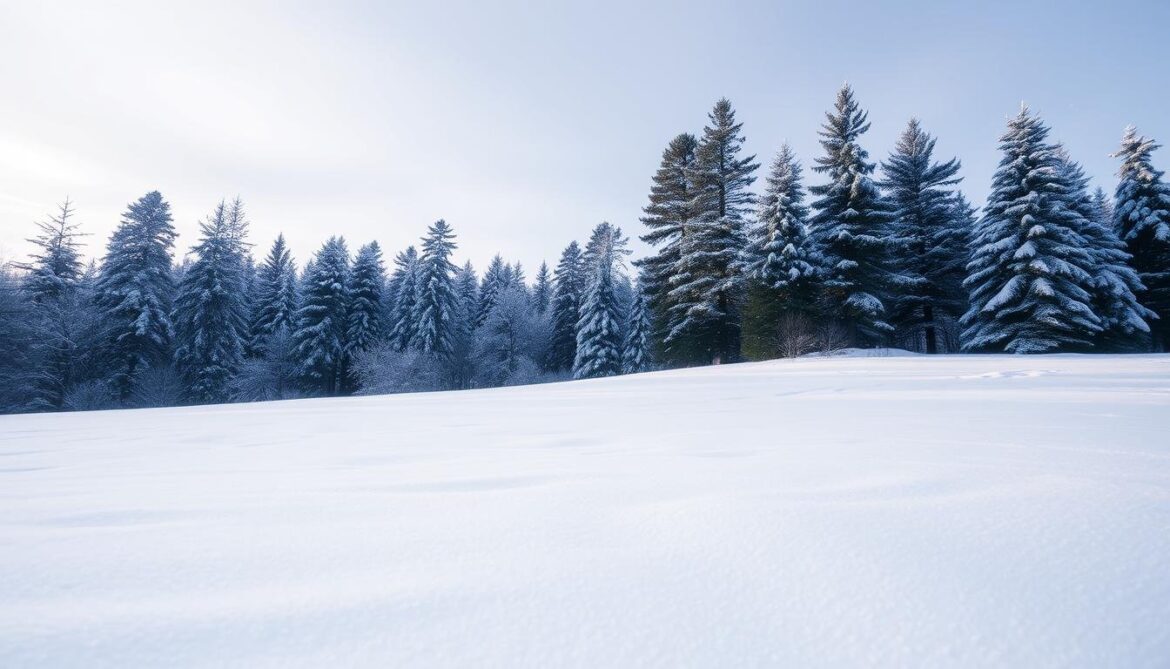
0,356 -> 1170,668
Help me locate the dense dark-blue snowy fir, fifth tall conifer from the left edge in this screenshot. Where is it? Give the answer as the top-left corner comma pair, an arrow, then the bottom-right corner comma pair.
293,237 -> 350,395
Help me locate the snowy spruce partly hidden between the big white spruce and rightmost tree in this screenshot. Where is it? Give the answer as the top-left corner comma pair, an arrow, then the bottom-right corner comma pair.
1058,157 -> 1154,352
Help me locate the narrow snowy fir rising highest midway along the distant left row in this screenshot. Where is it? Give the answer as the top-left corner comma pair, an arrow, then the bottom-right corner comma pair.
414,219 -> 459,364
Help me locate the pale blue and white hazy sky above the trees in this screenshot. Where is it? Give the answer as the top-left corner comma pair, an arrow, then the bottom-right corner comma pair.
0,0 -> 1170,277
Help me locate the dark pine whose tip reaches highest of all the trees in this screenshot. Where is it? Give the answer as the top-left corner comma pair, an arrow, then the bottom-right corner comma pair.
810,84 -> 899,345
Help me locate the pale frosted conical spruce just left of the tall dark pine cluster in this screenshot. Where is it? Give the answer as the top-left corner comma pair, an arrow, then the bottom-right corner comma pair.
573,222 -> 629,379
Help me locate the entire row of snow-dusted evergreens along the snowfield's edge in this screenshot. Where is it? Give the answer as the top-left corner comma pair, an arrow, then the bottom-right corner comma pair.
0,85 -> 1170,412
